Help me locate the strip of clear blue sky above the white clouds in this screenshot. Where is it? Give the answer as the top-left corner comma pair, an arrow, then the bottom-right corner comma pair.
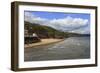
26,11 -> 90,20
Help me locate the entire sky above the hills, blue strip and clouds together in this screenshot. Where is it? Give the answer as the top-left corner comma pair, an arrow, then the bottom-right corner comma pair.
24,11 -> 90,34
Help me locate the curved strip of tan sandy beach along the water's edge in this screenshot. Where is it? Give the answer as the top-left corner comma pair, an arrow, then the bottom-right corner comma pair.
24,38 -> 64,48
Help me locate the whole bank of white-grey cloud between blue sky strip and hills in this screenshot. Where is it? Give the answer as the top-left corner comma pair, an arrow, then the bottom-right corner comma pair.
25,12 -> 90,33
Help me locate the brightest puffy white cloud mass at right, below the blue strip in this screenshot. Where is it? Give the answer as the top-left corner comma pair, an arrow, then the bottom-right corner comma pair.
50,16 -> 88,28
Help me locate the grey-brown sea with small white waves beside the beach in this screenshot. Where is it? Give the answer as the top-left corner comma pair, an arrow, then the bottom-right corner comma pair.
24,36 -> 90,61
